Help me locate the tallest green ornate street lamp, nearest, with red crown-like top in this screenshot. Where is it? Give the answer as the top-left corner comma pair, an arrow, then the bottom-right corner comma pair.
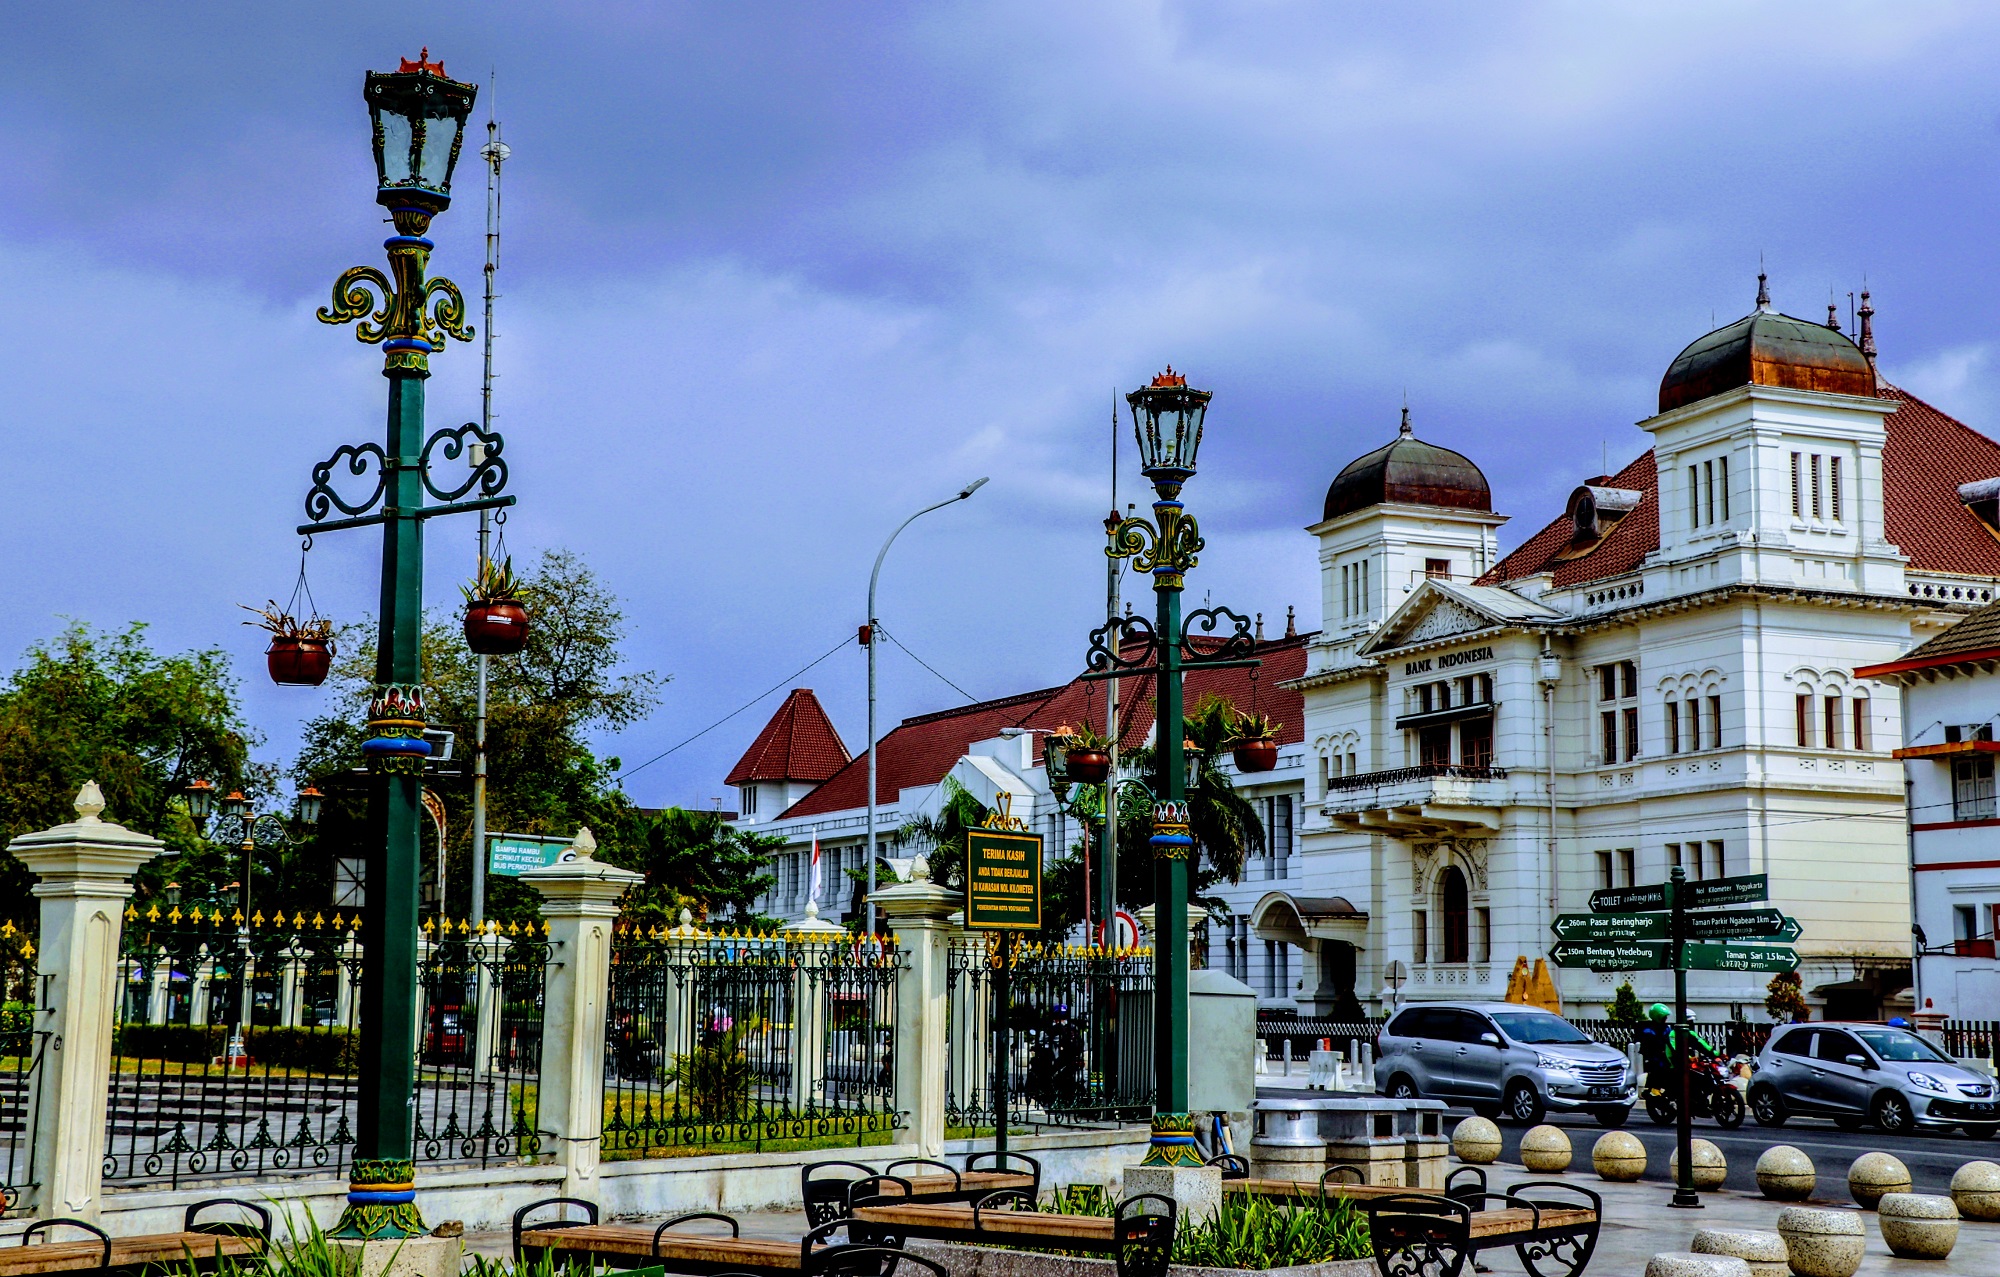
298,48 -> 514,1237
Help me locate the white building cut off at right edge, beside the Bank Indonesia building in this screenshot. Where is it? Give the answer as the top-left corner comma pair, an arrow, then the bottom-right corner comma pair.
1856,604 -> 2000,1019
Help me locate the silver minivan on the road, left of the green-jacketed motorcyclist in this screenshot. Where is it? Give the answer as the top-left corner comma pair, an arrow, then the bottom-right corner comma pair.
1376,1003 -> 1638,1127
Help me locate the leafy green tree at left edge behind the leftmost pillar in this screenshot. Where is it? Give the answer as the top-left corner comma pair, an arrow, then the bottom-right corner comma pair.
0,624 -> 258,925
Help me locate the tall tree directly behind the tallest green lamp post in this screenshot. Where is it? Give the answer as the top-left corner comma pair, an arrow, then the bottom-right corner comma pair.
292,550 -> 664,919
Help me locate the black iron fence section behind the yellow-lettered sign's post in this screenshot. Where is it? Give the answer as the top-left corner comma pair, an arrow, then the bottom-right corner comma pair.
944,937 -> 1154,1129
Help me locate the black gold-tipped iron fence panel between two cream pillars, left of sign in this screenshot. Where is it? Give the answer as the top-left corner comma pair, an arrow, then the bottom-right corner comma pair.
602,927 -> 902,1157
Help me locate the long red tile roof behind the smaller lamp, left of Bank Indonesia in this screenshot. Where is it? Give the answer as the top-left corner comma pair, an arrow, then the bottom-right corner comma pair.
780,634 -> 1310,819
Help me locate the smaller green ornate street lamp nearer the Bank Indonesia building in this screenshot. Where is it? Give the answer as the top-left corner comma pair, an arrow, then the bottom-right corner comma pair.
1084,366 -> 1258,1167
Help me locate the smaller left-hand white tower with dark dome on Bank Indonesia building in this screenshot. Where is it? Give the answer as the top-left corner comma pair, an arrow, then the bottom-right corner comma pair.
1306,408 -> 1506,664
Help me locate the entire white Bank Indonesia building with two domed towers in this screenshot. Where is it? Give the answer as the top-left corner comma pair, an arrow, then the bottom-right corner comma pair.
1252,286 -> 2000,1017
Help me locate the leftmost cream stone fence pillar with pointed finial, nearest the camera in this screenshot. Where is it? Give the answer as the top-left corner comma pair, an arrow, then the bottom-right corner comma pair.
8,783 -> 162,1223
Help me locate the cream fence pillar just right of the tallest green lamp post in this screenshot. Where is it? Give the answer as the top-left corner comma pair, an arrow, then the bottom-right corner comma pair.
518,829 -> 644,1201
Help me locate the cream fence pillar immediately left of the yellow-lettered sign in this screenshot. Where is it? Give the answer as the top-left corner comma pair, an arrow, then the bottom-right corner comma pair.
870,857 -> 964,1157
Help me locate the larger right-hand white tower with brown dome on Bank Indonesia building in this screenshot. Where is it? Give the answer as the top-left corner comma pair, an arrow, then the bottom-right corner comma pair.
1640,274 -> 1904,592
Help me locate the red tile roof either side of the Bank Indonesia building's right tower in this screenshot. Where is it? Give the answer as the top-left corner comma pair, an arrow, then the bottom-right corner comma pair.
1480,384 -> 2000,586
